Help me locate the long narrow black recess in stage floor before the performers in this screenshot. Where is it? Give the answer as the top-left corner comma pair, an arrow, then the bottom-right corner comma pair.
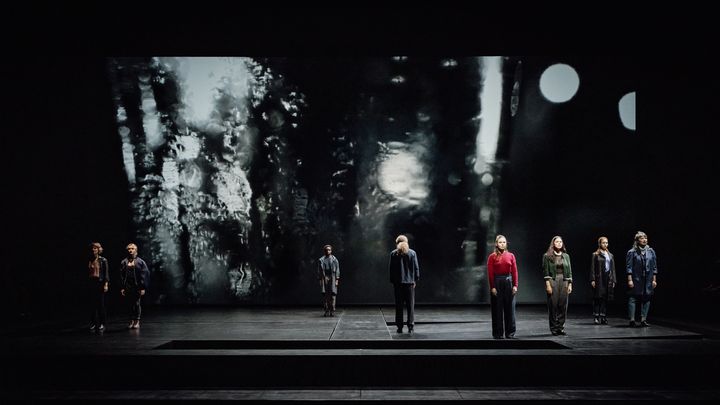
155,339 -> 569,350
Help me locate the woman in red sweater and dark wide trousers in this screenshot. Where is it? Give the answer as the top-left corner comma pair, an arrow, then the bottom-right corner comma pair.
487,235 -> 518,339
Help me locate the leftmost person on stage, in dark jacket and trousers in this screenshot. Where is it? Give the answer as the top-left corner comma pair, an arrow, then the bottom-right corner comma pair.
88,242 -> 110,332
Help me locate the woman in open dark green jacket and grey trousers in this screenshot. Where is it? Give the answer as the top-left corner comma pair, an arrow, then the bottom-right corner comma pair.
543,236 -> 572,336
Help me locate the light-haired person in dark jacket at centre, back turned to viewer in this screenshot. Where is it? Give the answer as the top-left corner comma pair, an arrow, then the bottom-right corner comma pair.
388,235 -> 420,335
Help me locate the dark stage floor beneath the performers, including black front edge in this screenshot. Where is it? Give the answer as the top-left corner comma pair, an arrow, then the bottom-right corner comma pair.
0,306 -> 720,401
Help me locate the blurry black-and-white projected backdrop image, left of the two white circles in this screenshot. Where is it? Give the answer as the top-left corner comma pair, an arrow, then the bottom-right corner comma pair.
109,56 -> 520,303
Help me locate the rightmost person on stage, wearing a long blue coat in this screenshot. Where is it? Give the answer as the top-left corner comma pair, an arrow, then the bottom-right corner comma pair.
625,231 -> 657,327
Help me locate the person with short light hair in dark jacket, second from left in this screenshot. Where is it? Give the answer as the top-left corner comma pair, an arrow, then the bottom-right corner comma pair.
120,243 -> 150,329
